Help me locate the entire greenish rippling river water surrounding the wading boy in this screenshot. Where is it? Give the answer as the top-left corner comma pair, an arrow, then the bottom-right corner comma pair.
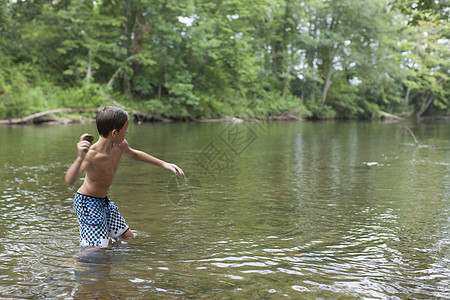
0,122 -> 450,299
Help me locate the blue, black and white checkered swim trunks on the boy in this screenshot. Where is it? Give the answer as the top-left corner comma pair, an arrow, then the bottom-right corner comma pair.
74,192 -> 130,248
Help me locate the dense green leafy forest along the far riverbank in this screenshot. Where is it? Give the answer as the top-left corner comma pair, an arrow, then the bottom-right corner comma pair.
0,0 -> 450,120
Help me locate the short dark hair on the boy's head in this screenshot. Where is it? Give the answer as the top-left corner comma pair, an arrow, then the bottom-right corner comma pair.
95,106 -> 128,137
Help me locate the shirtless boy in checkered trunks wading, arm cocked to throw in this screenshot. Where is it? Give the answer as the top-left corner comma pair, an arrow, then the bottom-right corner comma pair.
64,106 -> 184,248
